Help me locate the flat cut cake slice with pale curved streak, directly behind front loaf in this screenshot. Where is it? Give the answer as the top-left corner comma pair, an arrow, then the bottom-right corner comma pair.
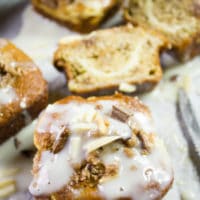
54,24 -> 167,95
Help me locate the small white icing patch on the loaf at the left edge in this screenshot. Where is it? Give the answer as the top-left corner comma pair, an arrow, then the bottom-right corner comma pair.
0,86 -> 18,105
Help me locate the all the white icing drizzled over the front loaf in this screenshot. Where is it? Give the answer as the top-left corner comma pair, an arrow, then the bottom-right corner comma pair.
29,100 -> 172,200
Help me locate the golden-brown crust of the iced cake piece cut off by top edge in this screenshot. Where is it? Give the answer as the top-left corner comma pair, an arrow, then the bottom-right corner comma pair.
32,0 -> 119,33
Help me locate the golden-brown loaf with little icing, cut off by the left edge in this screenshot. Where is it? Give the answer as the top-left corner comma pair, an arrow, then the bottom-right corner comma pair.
0,39 -> 47,143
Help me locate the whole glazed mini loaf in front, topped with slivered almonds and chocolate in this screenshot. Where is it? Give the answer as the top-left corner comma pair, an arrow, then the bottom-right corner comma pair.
29,94 -> 173,200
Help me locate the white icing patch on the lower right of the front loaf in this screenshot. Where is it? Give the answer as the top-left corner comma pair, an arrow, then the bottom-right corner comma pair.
98,139 -> 172,200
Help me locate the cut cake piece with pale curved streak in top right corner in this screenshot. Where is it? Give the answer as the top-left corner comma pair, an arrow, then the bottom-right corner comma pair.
124,0 -> 200,60
